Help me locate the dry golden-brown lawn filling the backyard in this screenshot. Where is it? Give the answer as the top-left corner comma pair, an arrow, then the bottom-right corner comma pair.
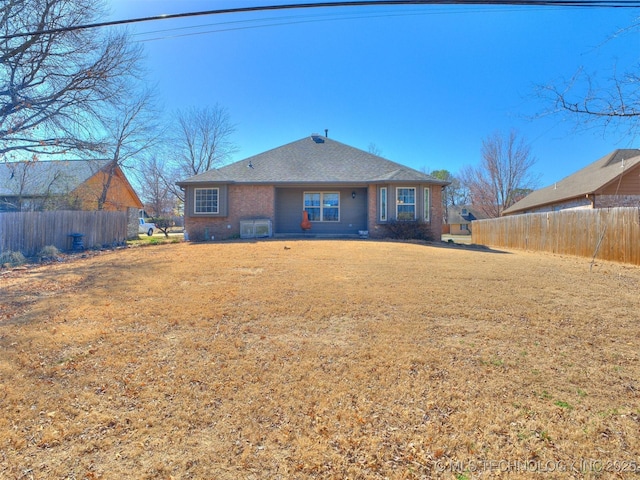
0,240 -> 640,479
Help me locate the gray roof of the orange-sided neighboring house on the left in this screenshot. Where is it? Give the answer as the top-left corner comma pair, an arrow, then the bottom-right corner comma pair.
0,160 -> 109,197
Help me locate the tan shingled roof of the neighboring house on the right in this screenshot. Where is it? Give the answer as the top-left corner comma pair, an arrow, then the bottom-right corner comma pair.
503,149 -> 640,215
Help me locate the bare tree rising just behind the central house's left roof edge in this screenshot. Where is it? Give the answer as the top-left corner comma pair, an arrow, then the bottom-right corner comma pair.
167,104 -> 237,201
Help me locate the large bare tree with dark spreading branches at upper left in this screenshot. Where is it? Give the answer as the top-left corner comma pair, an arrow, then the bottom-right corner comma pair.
0,0 -> 140,158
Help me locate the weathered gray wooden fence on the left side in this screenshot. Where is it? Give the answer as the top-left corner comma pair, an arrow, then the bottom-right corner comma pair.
0,211 -> 129,256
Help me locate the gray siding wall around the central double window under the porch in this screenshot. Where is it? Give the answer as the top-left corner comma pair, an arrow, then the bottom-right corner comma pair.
274,186 -> 367,235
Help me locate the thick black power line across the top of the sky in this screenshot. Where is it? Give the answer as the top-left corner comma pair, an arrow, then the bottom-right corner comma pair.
0,0 -> 640,40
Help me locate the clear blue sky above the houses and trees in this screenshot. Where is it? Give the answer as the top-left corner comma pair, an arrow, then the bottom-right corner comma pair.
109,0 -> 640,186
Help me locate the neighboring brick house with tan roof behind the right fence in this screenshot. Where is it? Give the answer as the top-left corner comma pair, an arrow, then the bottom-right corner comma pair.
502,149 -> 640,215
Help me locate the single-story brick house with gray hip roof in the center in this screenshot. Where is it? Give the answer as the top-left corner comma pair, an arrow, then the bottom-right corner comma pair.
177,134 -> 448,240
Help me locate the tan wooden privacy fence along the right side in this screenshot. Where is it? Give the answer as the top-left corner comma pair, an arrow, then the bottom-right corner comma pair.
471,207 -> 640,265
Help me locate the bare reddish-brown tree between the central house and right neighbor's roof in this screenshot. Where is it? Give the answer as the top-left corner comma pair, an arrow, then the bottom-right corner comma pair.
461,131 -> 540,218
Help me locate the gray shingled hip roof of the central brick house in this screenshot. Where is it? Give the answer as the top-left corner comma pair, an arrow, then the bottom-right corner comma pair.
178,135 -> 449,185
